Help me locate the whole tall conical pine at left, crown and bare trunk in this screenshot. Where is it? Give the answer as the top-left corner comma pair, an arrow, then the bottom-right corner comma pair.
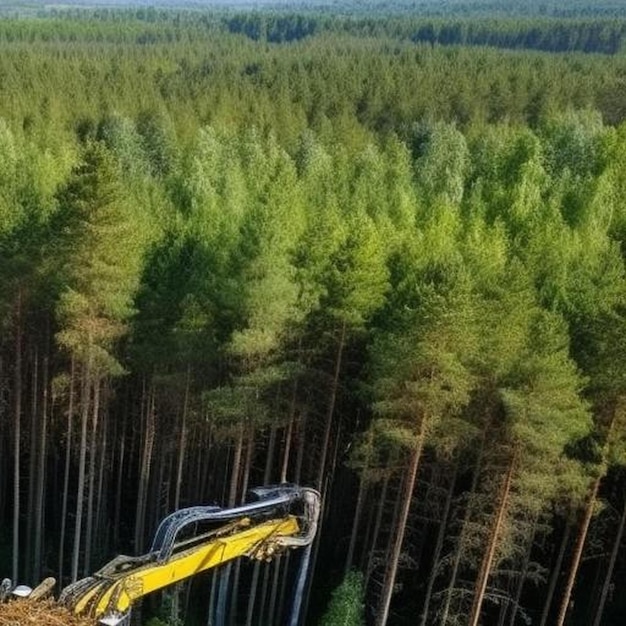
55,143 -> 141,580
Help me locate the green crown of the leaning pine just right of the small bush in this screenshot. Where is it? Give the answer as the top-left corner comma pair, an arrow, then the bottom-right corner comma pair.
370,255 -> 477,453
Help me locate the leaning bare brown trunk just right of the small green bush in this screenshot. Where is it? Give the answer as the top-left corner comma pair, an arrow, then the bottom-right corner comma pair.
374,417 -> 426,626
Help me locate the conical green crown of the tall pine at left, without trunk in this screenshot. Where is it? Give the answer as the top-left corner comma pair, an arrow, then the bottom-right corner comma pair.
54,143 -> 141,373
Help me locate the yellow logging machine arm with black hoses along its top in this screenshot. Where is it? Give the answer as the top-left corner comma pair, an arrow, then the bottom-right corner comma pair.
3,485 -> 320,626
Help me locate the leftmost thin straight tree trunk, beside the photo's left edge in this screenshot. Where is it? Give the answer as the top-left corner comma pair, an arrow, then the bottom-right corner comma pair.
12,289 -> 22,581
